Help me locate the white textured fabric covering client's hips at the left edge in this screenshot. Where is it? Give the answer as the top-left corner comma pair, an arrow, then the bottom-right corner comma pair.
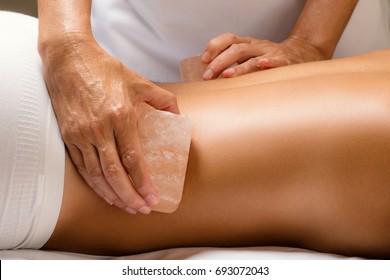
0,12 -> 65,249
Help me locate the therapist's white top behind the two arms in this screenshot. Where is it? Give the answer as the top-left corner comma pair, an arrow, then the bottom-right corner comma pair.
92,0 -> 390,82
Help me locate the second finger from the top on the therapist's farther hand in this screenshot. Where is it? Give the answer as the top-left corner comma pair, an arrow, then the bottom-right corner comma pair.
203,43 -> 259,80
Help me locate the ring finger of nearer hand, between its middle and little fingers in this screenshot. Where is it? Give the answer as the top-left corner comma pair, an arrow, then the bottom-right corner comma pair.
81,145 -> 131,213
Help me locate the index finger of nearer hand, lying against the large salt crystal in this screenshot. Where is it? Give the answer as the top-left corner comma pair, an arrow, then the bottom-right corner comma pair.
114,111 -> 159,210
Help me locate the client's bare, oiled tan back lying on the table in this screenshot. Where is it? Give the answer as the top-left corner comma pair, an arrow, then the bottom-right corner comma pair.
44,50 -> 390,258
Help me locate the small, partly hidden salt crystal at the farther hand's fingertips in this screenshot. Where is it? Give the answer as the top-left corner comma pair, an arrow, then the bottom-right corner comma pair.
180,55 -> 207,82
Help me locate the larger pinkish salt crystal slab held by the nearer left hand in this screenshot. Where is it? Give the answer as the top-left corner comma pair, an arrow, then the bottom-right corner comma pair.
137,103 -> 191,213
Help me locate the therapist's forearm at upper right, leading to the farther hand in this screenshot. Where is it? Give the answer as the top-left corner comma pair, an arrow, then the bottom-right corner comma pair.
289,0 -> 357,59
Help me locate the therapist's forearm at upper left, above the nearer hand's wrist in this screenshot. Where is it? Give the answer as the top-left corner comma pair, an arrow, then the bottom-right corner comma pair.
38,0 -> 92,55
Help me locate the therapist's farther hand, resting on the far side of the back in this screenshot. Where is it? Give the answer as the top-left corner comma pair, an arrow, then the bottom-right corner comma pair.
202,33 -> 329,80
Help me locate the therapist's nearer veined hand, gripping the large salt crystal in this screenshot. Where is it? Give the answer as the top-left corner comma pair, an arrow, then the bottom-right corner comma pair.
40,36 -> 179,214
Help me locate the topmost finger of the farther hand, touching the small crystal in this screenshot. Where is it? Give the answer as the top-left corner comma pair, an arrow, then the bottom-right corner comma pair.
202,33 -> 249,64
